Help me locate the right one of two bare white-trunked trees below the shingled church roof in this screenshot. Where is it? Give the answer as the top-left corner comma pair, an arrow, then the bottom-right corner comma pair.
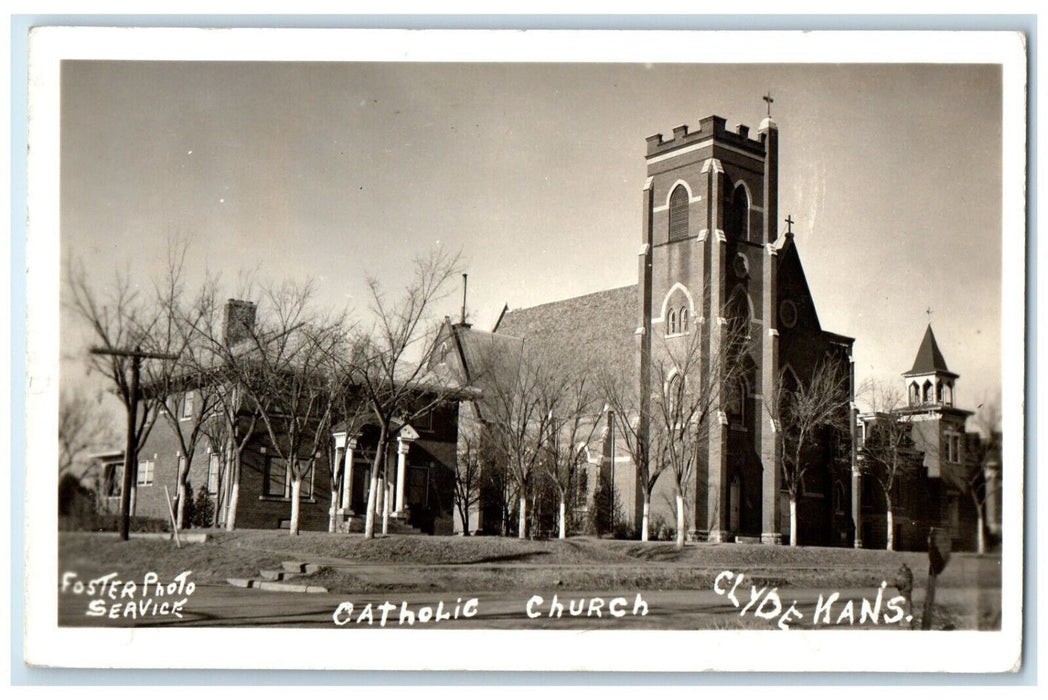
540,371 -> 603,540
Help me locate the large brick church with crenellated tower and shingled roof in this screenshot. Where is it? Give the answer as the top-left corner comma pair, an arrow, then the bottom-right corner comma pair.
444,110 -> 858,546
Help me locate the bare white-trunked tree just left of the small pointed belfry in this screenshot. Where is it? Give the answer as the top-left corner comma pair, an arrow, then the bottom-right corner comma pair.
859,382 -> 921,550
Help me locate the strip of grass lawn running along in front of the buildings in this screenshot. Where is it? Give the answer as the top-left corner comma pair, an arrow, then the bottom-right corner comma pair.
59,530 -> 1001,593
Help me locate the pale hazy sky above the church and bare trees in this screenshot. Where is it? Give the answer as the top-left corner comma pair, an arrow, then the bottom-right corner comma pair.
61,61 -> 1006,409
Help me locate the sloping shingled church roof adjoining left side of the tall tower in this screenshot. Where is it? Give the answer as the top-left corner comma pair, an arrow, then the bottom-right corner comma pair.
496,285 -> 638,383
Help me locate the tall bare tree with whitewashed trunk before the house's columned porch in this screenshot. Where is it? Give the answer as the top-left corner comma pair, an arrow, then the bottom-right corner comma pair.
343,249 -> 458,539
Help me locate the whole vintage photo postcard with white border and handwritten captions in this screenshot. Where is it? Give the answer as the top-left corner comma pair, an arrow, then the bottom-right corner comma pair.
25,27 -> 1026,673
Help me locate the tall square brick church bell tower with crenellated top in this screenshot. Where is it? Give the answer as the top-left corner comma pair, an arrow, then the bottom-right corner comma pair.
636,109 -> 781,542
